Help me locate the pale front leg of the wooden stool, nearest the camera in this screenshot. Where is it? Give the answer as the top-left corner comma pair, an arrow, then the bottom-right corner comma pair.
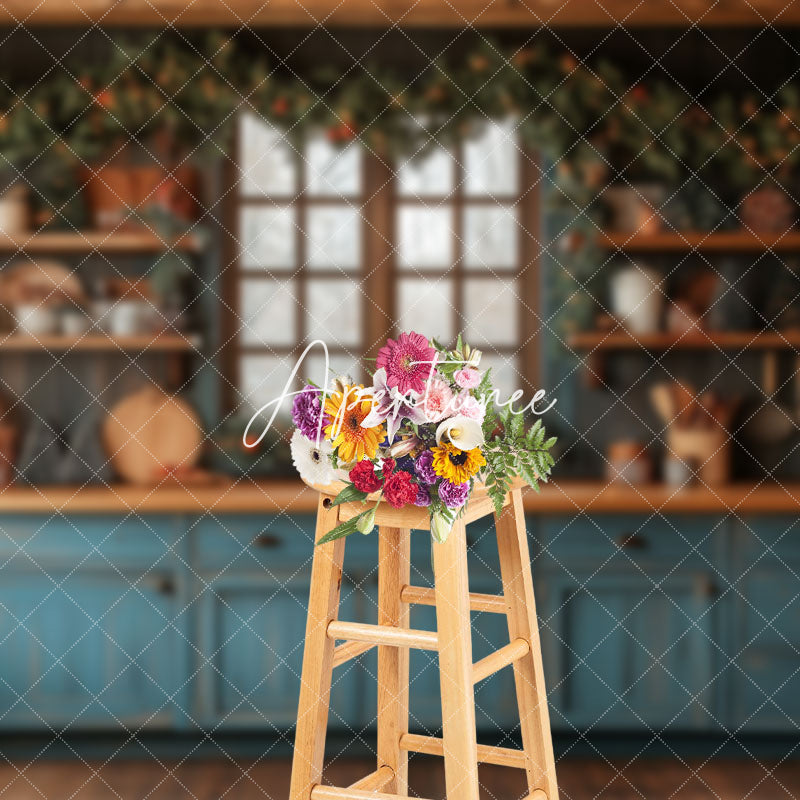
433,520 -> 479,800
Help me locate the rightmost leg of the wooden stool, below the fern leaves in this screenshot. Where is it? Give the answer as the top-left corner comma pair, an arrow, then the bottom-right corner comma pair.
495,489 -> 558,800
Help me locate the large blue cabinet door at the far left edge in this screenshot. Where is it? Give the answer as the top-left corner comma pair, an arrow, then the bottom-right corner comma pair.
0,573 -> 183,730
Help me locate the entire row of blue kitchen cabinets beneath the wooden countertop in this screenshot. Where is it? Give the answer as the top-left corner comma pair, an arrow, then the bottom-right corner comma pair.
0,512 -> 800,740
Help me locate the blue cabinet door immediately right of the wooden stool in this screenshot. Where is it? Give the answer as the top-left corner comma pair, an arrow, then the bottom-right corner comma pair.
541,573 -> 716,731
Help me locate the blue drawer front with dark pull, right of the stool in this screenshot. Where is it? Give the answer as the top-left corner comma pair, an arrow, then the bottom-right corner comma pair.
541,514 -> 723,565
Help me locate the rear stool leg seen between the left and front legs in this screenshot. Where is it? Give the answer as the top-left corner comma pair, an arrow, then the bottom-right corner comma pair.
378,526 -> 411,796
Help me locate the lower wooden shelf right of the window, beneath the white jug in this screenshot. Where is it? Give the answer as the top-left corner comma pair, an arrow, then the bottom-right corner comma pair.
568,330 -> 800,351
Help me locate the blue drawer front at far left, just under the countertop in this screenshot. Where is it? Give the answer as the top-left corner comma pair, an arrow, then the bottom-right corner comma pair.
0,514 -> 181,568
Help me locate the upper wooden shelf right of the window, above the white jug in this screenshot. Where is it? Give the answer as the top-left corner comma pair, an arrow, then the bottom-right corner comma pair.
599,231 -> 800,254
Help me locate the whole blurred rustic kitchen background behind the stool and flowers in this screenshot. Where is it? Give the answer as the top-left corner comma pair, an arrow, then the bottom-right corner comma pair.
0,0 -> 800,800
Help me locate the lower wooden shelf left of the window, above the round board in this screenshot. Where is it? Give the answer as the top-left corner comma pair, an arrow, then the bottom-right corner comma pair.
0,333 -> 200,353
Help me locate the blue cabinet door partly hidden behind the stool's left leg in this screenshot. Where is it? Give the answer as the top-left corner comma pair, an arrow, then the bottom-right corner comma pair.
197,576 -> 357,732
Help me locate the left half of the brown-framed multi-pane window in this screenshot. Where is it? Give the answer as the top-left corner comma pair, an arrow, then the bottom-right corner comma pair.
232,113 -> 365,408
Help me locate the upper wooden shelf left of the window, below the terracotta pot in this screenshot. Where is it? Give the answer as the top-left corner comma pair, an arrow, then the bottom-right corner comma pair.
0,231 -> 199,255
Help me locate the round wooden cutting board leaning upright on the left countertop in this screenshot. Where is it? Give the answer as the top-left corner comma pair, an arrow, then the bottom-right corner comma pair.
102,386 -> 203,484
